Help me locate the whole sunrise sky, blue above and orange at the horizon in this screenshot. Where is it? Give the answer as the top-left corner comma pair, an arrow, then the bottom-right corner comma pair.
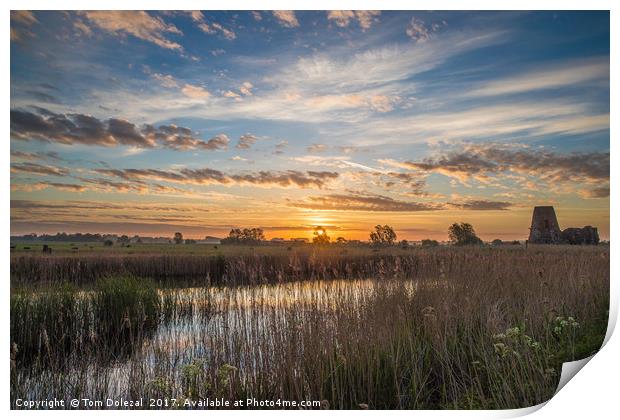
10,11 -> 610,240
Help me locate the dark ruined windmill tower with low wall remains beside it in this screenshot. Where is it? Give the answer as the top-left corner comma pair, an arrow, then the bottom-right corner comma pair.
528,206 -> 599,245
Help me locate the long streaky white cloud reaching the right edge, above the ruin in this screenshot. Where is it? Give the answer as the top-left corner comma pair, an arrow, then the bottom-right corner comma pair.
356,99 -> 609,146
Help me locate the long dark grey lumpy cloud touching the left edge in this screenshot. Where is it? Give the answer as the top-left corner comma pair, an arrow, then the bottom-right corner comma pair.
11,108 -> 230,150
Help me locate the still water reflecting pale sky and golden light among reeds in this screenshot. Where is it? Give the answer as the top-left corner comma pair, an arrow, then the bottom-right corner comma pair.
17,280 -> 416,399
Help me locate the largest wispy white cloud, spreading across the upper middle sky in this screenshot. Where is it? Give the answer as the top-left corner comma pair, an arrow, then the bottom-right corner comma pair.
72,27 -> 502,128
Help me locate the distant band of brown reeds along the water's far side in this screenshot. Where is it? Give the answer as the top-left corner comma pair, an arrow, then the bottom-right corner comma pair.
10,245 -> 609,287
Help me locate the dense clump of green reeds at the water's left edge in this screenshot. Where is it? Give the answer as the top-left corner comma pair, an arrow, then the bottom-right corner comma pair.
11,276 -> 161,364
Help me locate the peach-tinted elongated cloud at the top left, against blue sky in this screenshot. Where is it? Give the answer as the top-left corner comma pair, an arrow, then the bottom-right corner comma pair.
79,10 -> 183,51
